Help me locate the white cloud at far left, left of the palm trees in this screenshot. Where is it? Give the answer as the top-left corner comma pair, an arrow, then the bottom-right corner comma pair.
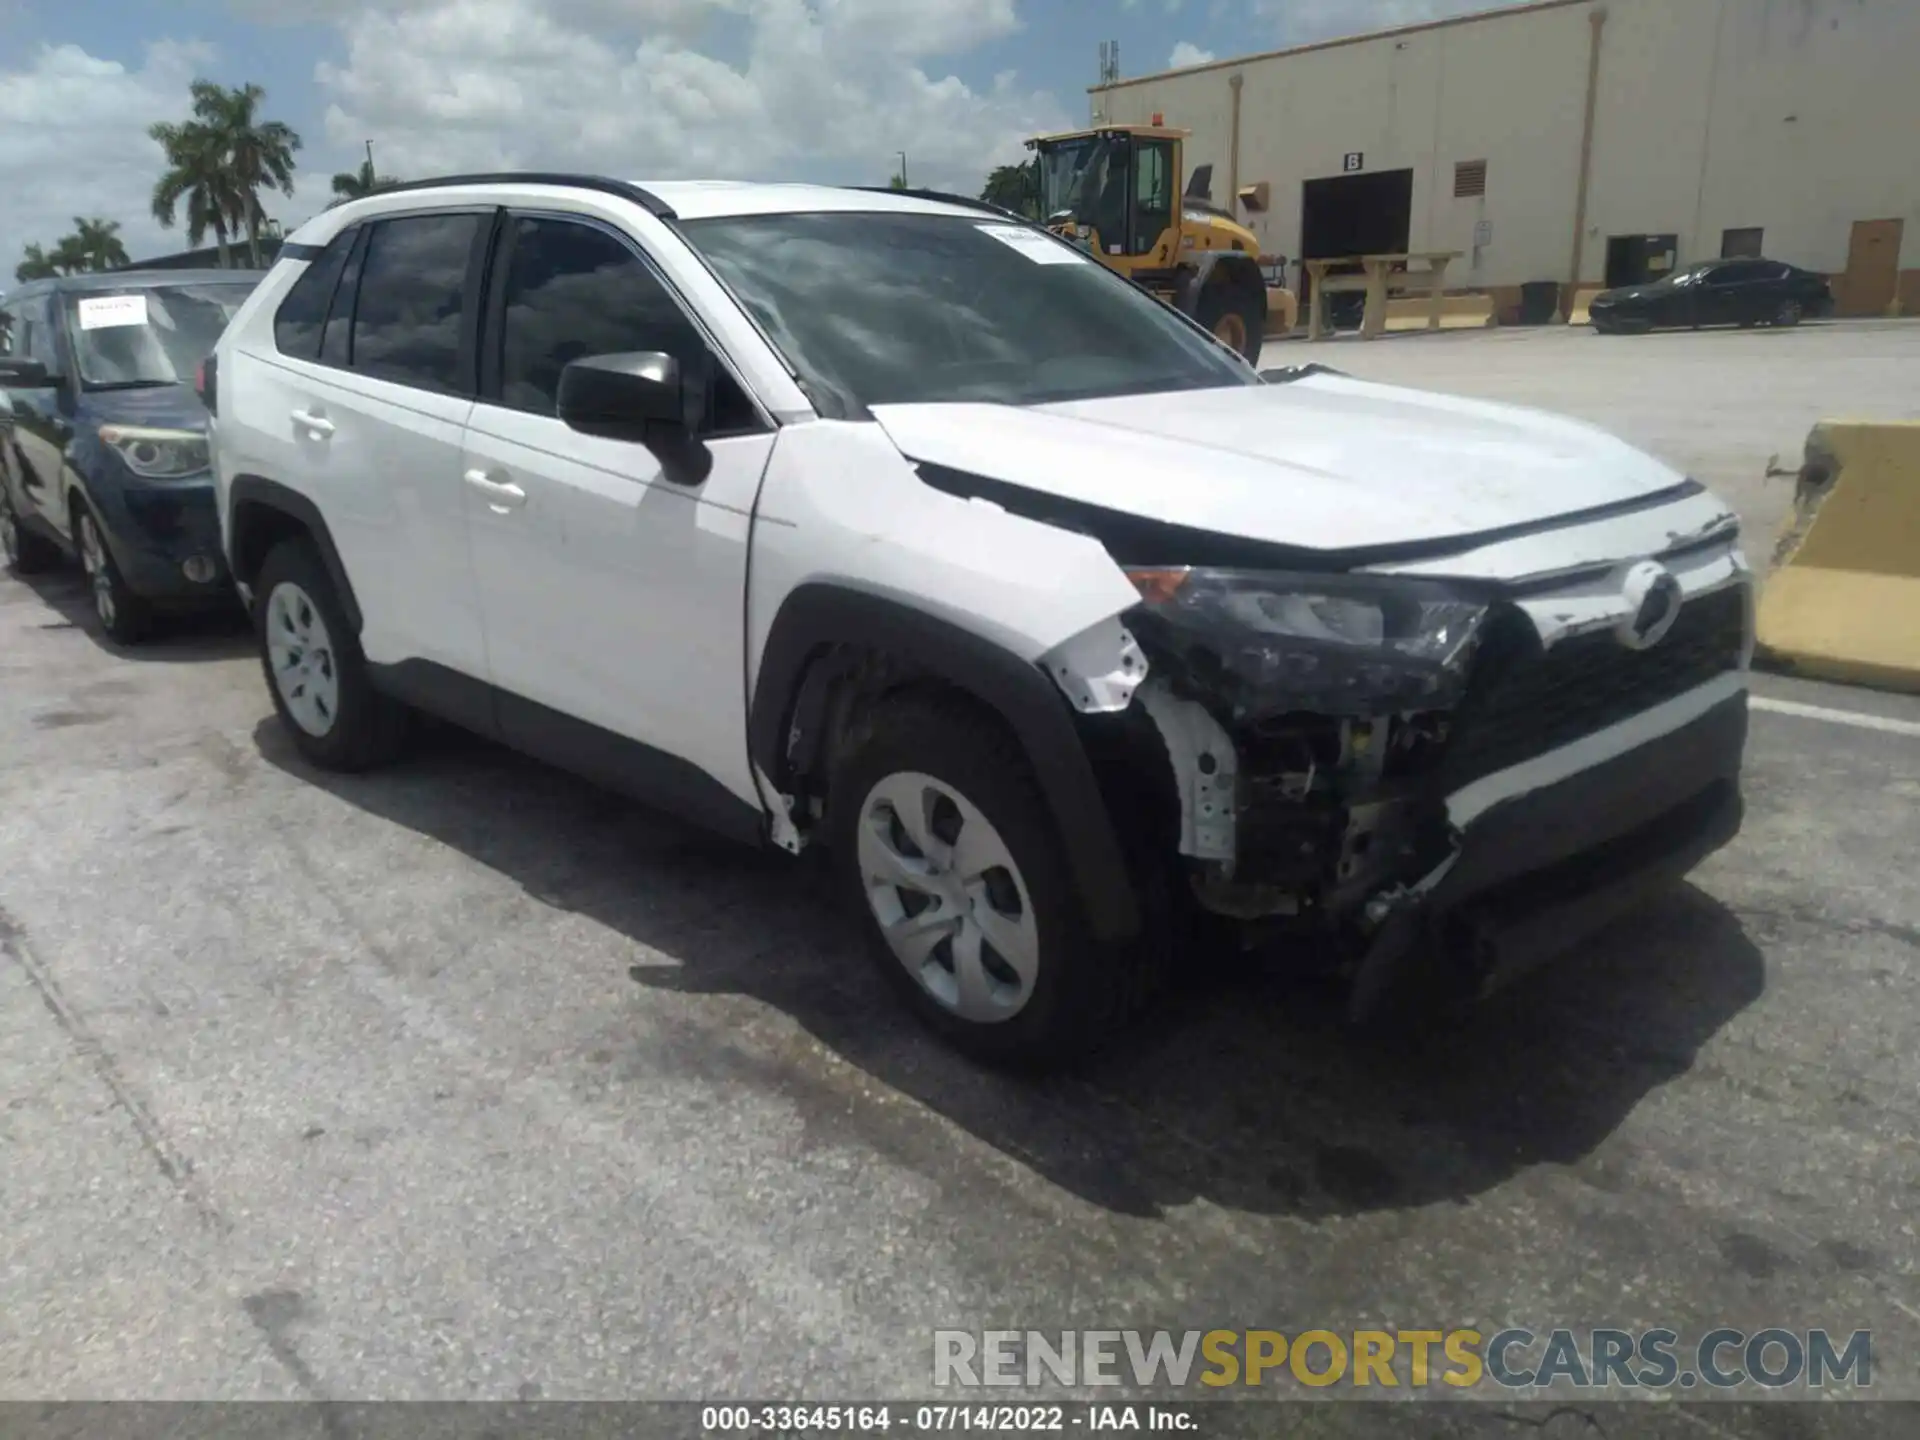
0,42 -> 211,288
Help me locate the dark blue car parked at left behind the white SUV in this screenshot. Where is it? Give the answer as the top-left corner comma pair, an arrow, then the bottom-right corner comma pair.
0,271 -> 261,643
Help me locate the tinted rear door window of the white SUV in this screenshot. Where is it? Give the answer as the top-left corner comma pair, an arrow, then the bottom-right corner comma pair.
353,215 -> 482,392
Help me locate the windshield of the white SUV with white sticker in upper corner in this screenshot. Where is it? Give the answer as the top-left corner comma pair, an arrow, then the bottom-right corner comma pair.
684,211 -> 1260,419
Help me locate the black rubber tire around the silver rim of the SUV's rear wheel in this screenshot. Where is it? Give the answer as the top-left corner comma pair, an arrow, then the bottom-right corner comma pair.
253,538 -> 407,774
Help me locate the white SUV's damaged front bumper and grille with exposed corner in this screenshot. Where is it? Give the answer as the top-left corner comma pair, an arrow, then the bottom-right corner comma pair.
1036,538 -> 1753,1018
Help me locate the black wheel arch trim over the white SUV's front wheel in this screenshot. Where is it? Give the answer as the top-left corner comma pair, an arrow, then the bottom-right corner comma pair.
747,582 -> 1142,941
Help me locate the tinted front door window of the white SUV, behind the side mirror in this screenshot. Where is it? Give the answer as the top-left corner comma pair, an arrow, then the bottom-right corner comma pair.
499,219 -> 760,434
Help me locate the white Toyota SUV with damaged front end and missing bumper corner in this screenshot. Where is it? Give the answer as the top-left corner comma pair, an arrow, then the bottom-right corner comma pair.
204,175 -> 1751,1062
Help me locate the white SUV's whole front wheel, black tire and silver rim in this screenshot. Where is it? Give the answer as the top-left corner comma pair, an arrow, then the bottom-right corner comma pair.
829,697 -> 1144,1068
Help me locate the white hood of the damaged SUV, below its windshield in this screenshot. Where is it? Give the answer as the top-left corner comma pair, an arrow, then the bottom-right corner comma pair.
874,374 -> 1688,553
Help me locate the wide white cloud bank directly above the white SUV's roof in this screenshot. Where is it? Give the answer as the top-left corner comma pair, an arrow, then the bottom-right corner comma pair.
315,0 -> 1068,201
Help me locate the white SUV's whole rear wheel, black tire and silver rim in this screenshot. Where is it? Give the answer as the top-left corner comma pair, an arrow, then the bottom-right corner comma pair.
253,540 -> 407,772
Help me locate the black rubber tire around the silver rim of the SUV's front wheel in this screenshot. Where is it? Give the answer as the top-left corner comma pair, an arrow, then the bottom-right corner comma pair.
828,695 -> 1152,1069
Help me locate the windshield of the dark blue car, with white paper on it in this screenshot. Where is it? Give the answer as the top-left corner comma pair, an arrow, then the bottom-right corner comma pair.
67,280 -> 255,390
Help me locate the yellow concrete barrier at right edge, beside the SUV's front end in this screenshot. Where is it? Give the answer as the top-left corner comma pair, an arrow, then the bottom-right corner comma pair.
1757,420 -> 1920,691
